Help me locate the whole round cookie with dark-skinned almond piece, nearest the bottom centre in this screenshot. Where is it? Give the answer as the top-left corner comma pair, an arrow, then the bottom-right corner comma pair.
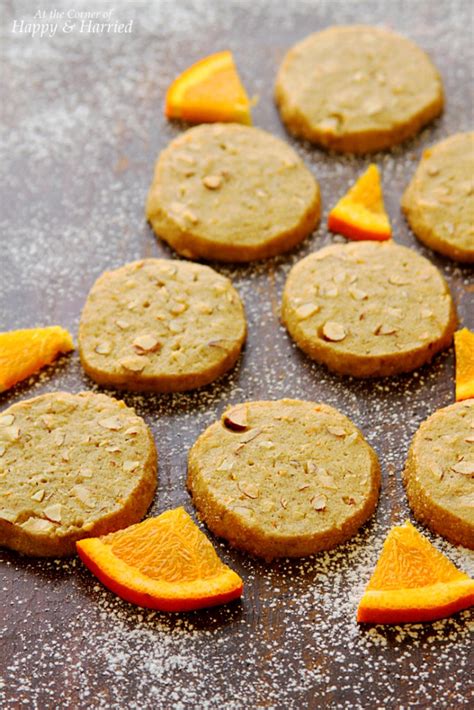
188,399 -> 380,560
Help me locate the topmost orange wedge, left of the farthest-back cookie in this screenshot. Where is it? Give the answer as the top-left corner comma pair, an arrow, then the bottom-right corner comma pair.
165,51 -> 252,125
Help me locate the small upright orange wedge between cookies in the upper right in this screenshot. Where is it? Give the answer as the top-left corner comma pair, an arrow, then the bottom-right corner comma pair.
328,164 -> 392,241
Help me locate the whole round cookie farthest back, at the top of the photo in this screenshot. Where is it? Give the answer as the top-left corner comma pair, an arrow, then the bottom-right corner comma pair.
275,25 -> 443,153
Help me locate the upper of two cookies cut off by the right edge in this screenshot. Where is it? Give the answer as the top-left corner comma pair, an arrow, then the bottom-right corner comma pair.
402,132 -> 474,263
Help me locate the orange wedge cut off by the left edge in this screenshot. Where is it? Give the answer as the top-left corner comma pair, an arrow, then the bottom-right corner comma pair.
0,325 -> 74,392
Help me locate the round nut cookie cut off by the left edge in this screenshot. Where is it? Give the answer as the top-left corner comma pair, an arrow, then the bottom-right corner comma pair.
0,392 -> 157,557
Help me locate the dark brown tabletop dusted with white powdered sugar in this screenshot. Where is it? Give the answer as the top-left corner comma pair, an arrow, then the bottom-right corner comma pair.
0,0 -> 474,708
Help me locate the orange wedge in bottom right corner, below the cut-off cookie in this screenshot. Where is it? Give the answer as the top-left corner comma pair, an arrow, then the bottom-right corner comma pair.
357,522 -> 474,624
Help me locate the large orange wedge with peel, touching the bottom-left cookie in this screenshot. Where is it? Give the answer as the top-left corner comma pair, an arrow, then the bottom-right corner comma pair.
76,508 -> 243,611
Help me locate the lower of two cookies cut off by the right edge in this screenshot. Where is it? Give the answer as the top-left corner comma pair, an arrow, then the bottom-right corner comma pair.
403,399 -> 474,550
